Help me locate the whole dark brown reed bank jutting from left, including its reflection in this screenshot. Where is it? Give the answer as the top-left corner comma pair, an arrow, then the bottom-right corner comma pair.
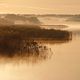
0,27 -> 72,63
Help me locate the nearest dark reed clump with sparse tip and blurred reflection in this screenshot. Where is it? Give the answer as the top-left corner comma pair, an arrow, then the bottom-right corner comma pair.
0,40 -> 52,63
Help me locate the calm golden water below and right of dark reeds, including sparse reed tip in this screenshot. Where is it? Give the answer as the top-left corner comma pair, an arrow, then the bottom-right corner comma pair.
0,17 -> 80,80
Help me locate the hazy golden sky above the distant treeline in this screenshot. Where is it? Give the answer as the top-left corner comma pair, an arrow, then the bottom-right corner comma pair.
0,0 -> 80,14
